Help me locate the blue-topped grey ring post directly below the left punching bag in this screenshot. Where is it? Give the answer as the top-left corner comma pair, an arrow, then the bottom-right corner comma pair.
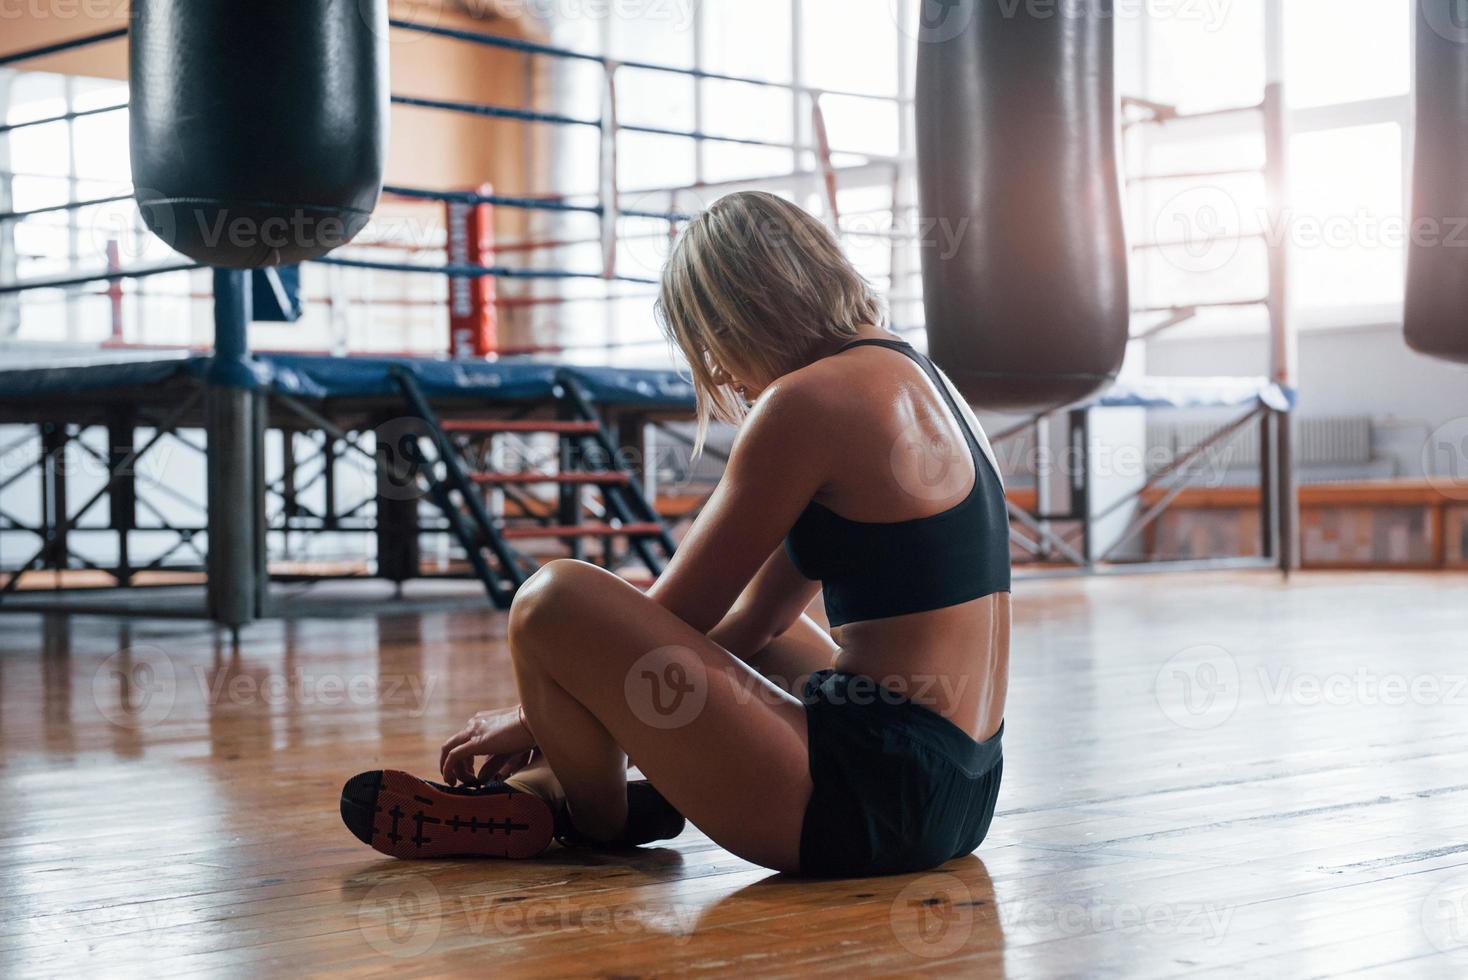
206,268 -> 266,635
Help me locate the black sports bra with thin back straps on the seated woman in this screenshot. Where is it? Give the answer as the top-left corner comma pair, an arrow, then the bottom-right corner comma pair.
785,340 -> 1010,626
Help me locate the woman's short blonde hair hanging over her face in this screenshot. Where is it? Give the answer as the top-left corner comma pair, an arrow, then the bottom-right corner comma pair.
656,191 -> 885,453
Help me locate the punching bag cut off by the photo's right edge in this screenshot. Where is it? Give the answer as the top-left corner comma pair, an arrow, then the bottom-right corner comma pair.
1405,0 -> 1468,362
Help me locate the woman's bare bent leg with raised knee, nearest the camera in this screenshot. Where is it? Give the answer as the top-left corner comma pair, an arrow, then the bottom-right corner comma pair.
509,560 -> 810,871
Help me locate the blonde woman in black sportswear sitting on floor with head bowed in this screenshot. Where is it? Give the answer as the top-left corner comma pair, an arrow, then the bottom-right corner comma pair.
342,192 -> 1010,876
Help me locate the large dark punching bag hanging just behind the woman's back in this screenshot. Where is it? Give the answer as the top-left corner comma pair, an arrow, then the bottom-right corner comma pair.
916,0 -> 1130,412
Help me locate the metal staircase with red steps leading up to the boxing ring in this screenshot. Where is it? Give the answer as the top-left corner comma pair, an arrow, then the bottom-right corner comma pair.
393,370 -> 675,609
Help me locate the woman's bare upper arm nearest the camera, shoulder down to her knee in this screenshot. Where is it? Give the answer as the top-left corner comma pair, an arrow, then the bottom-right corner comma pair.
647,380 -> 837,634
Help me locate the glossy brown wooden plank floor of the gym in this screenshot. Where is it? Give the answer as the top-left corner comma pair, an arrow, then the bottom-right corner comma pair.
0,574 -> 1468,977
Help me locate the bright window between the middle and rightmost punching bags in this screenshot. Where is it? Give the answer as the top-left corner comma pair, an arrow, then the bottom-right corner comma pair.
1127,0 -> 1415,329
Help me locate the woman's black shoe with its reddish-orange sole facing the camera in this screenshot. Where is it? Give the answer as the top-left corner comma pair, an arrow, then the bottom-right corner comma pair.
342,769 -> 555,858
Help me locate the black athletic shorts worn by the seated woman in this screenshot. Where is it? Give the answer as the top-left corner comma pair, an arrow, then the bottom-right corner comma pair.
800,670 -> 1004,877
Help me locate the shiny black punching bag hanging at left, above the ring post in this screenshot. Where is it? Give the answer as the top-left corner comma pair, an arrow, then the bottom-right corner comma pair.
129,0 -> 388,268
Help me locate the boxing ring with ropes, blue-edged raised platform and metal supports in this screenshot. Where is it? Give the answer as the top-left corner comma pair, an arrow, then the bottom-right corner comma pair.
0,21 -> 1293,628
